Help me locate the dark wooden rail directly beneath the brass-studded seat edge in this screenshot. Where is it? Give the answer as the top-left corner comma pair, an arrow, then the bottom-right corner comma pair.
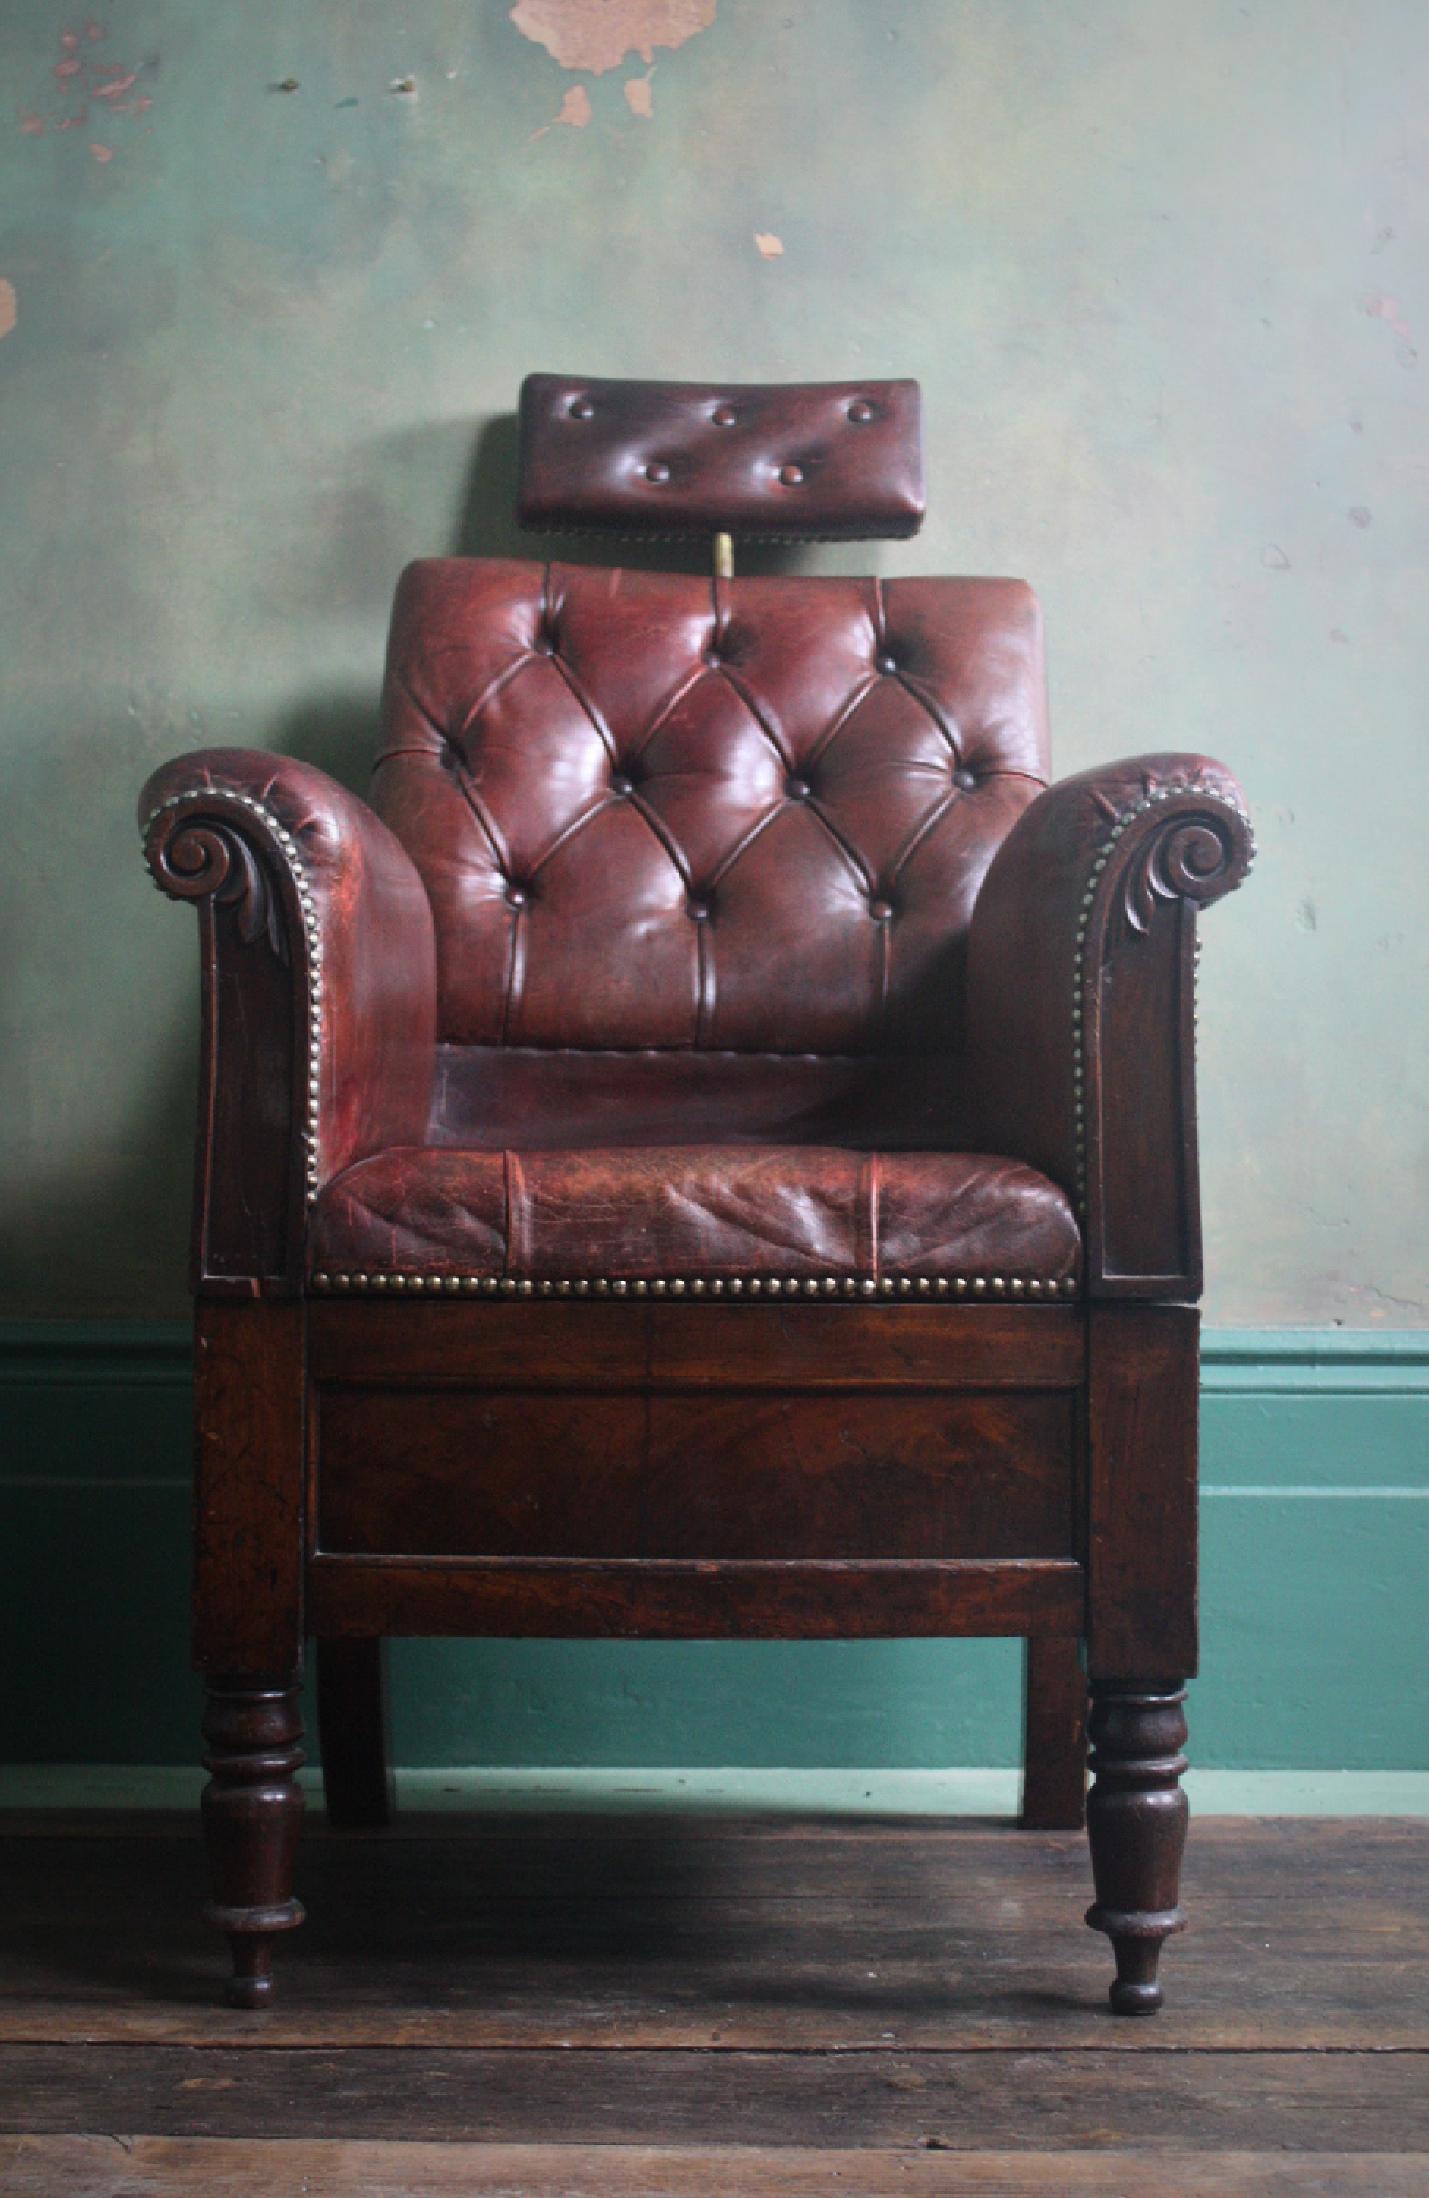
308,1297 -> 1084,1389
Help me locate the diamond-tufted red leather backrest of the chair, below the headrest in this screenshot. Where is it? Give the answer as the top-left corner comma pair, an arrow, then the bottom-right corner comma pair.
374,558 -> 1046,1081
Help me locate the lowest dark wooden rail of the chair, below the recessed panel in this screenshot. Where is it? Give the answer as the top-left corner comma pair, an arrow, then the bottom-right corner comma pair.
308,1556 -> 1084,1640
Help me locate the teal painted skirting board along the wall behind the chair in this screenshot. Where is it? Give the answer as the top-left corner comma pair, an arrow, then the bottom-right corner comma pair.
0,1323 -> 1429,1775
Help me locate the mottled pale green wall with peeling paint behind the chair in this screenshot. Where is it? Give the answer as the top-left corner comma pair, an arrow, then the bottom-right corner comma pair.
0,0 -> 1429,1318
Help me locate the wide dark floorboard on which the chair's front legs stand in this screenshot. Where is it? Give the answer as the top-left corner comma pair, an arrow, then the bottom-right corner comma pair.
0,1816 -> 1429,2051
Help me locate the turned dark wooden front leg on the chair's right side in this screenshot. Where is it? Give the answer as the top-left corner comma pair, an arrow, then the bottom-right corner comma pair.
1086,1679 -> 1187,2016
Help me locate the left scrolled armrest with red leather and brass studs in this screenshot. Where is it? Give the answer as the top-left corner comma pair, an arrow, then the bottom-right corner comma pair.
139,747 -> 435,1295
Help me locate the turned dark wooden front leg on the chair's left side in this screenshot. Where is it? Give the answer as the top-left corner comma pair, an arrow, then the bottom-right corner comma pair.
202,1677 -> 303,2007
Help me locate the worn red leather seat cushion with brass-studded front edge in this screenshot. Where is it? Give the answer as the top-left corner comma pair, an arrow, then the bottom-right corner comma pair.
310,1145 -> 1079,1297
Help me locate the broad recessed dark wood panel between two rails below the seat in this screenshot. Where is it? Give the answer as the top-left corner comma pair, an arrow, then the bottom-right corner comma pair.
319,1389 -> 1075,1558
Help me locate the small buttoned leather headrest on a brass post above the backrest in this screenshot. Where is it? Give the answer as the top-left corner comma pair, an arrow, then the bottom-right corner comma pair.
517,374 -> 923,541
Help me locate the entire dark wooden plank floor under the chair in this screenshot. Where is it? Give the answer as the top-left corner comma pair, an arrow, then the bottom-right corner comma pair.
0,1816 -> 1429,2198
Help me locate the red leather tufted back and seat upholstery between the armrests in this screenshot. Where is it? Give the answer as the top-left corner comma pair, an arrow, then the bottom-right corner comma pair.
296,558 -> 1077,1292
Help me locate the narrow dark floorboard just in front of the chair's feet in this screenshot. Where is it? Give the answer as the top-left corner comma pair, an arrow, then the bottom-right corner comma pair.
0,2044 -> 1429,2152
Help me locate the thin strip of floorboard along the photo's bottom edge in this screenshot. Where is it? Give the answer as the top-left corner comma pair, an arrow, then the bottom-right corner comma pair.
0,2136 -> 1425,2198
